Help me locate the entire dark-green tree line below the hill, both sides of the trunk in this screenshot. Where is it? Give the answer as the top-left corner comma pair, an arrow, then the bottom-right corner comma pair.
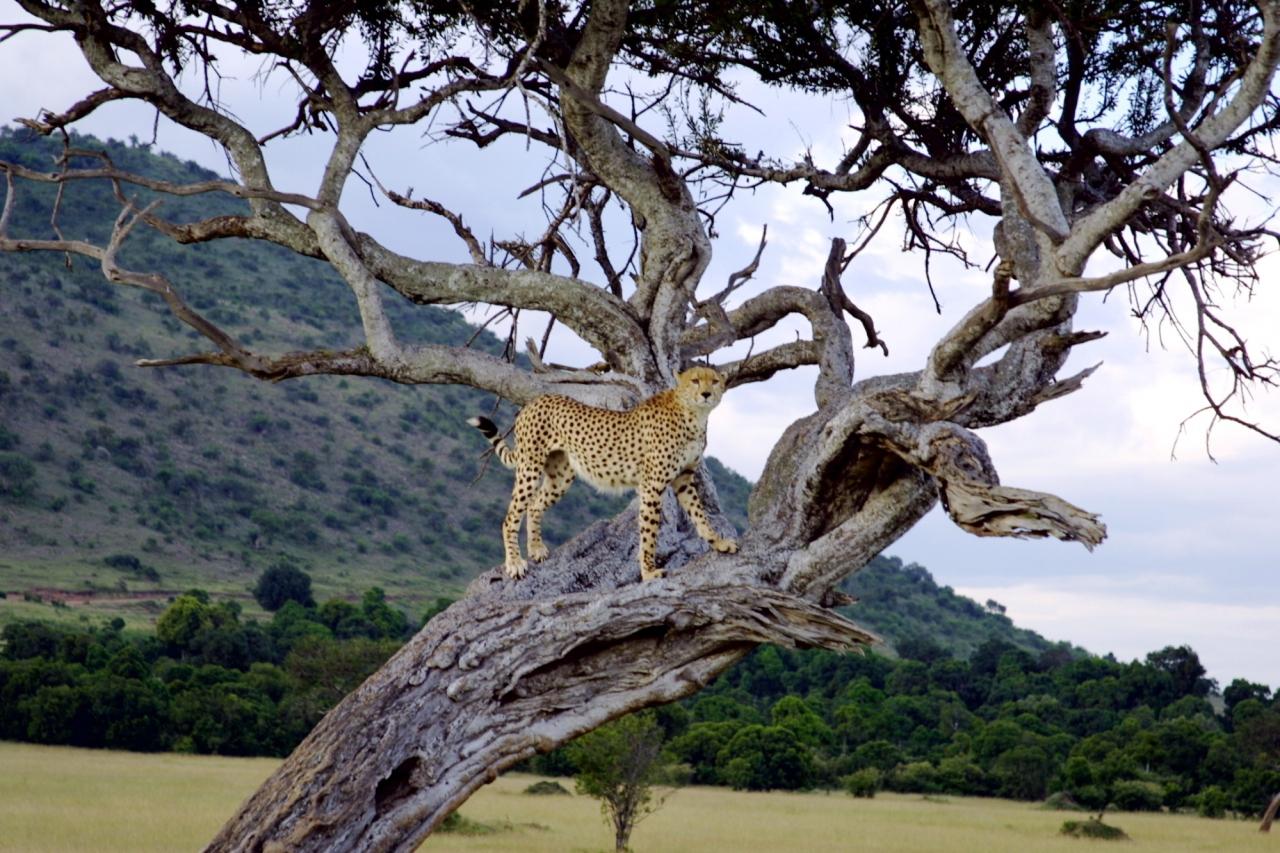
0,578 -> 1280,817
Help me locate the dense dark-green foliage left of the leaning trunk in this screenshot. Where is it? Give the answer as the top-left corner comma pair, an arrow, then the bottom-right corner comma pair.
0,588 -> 410,756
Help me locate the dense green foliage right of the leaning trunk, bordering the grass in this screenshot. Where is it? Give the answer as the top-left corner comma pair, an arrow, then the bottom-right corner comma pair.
645,639 -> 1280,815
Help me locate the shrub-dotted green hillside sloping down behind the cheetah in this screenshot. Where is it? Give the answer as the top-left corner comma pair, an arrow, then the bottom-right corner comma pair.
0,129 -> 1048,652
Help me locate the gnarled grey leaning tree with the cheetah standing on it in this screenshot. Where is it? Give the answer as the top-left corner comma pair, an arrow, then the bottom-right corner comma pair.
0,0 -> 1280,850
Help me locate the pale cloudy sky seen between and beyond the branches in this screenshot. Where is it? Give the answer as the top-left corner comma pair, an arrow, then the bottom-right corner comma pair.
0,0 -> 1280,688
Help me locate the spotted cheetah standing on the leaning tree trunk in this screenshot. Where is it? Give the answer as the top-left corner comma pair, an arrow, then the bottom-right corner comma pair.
467,366 -> 737,580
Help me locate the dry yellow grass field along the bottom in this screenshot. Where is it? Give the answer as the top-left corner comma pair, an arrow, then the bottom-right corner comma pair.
0,743 -> 1280,853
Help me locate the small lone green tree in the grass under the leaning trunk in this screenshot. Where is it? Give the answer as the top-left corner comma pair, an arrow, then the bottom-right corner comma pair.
568,711 -> 667,853
